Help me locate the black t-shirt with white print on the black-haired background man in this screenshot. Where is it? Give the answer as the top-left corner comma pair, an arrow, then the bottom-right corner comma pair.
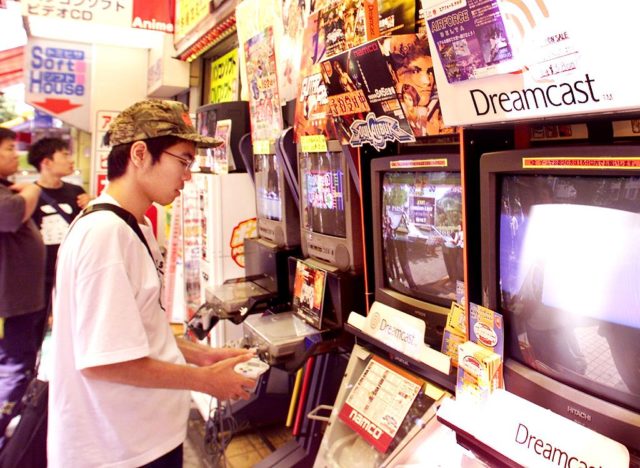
31,182 -> 85,283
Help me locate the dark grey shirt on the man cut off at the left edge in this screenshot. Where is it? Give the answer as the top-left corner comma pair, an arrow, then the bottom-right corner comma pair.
0,179 -> 45,317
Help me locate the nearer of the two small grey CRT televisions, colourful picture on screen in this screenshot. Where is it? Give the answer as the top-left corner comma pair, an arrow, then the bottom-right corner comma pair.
298,140 -> 363,271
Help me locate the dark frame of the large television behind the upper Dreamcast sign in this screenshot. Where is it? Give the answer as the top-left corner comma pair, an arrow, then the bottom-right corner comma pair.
371,151 -> 466,350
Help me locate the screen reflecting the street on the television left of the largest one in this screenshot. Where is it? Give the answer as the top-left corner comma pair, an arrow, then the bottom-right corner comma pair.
381,172 -> 464,305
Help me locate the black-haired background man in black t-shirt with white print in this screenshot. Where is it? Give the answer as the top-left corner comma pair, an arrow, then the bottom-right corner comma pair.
28,138 -> 90,314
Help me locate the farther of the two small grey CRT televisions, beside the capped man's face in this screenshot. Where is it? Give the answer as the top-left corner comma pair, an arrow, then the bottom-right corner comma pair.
253,151 -> 300,247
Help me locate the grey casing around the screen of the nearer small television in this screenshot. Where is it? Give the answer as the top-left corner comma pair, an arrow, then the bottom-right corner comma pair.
298,140 -> 364,271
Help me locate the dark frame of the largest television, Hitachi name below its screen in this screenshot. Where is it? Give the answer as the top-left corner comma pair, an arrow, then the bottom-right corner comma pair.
480,145 -> 640,456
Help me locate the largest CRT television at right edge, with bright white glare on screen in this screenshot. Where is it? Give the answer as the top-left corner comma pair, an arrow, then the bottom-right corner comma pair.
480,146 -> 640,457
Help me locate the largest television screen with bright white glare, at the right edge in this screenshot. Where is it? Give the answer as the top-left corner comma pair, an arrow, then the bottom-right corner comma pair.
497,175 -> 640,411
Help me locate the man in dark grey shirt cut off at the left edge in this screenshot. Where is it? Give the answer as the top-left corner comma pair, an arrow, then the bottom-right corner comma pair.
0,128 -> 46,447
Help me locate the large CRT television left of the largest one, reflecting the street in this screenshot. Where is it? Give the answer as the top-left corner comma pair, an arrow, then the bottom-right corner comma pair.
371,153 -> 464,350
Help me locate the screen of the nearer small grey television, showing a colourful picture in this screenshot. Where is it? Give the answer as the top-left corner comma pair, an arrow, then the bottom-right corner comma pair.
300,152 -> 347,238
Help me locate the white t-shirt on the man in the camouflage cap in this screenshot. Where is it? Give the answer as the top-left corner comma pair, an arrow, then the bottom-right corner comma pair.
47,194 -> 189,468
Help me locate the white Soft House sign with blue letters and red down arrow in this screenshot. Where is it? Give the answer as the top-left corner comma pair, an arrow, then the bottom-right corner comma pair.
24,39 -> 91,132
